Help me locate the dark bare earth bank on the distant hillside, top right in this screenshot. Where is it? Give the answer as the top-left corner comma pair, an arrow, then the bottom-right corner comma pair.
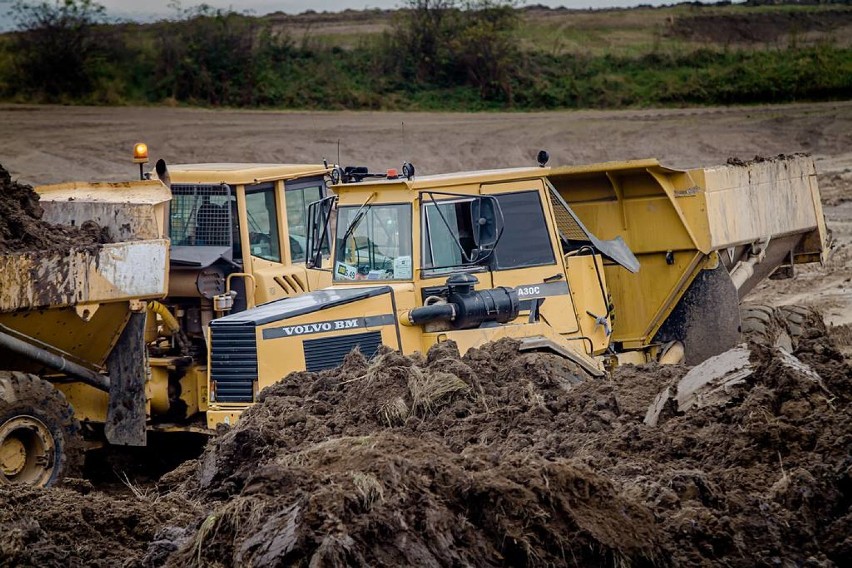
667,10 -> 852,44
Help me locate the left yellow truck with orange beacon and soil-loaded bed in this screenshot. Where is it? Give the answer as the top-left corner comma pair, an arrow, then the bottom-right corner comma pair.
0,150 -> 342,485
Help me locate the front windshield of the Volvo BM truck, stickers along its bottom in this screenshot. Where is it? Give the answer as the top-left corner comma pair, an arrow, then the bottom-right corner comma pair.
334,203 -> 412,281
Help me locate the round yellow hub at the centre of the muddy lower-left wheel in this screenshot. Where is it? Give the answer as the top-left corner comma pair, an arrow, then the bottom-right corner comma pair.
0,416 -> 56,485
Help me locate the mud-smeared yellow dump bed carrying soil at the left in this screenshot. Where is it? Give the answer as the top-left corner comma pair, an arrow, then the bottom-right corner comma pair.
0,181 -> 171,372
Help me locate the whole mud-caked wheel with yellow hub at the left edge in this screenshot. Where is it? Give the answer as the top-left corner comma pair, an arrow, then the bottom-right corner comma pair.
0,371 -> 85,487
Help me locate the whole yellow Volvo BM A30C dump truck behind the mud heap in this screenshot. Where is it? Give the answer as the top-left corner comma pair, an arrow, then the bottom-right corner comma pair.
208,156 -> 827,427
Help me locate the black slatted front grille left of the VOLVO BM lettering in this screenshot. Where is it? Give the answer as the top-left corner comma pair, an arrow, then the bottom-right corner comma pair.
210,325 -> 257,402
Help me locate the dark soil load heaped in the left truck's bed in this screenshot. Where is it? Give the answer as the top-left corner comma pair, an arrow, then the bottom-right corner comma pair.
0,165 -> 111,254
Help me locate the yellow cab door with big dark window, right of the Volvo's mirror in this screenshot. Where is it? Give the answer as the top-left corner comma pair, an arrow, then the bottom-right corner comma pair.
481,179 -> 579,334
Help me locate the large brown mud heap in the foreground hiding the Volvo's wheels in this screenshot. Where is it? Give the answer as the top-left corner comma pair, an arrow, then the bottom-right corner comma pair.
153,332 -> 852,566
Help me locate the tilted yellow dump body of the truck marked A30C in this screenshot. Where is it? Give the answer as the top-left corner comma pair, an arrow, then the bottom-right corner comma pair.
548,156 -> 828,363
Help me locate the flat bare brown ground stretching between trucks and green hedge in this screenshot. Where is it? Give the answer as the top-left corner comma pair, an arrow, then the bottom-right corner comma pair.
0,101 -> 852,325
